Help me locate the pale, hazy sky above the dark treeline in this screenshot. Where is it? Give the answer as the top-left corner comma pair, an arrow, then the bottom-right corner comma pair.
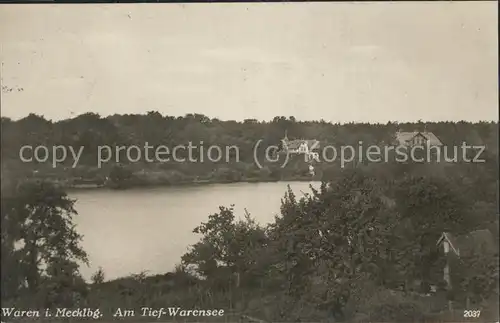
0,1 -> 498,123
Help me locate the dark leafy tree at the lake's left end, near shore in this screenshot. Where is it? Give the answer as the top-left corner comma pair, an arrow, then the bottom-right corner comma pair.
1,182 -> 87,305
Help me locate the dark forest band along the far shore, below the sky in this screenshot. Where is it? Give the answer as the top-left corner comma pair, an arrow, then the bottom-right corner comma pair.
1,111 -> 498,188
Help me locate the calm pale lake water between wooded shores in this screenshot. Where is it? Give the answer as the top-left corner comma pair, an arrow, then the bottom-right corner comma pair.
70,182 -> 319,279
